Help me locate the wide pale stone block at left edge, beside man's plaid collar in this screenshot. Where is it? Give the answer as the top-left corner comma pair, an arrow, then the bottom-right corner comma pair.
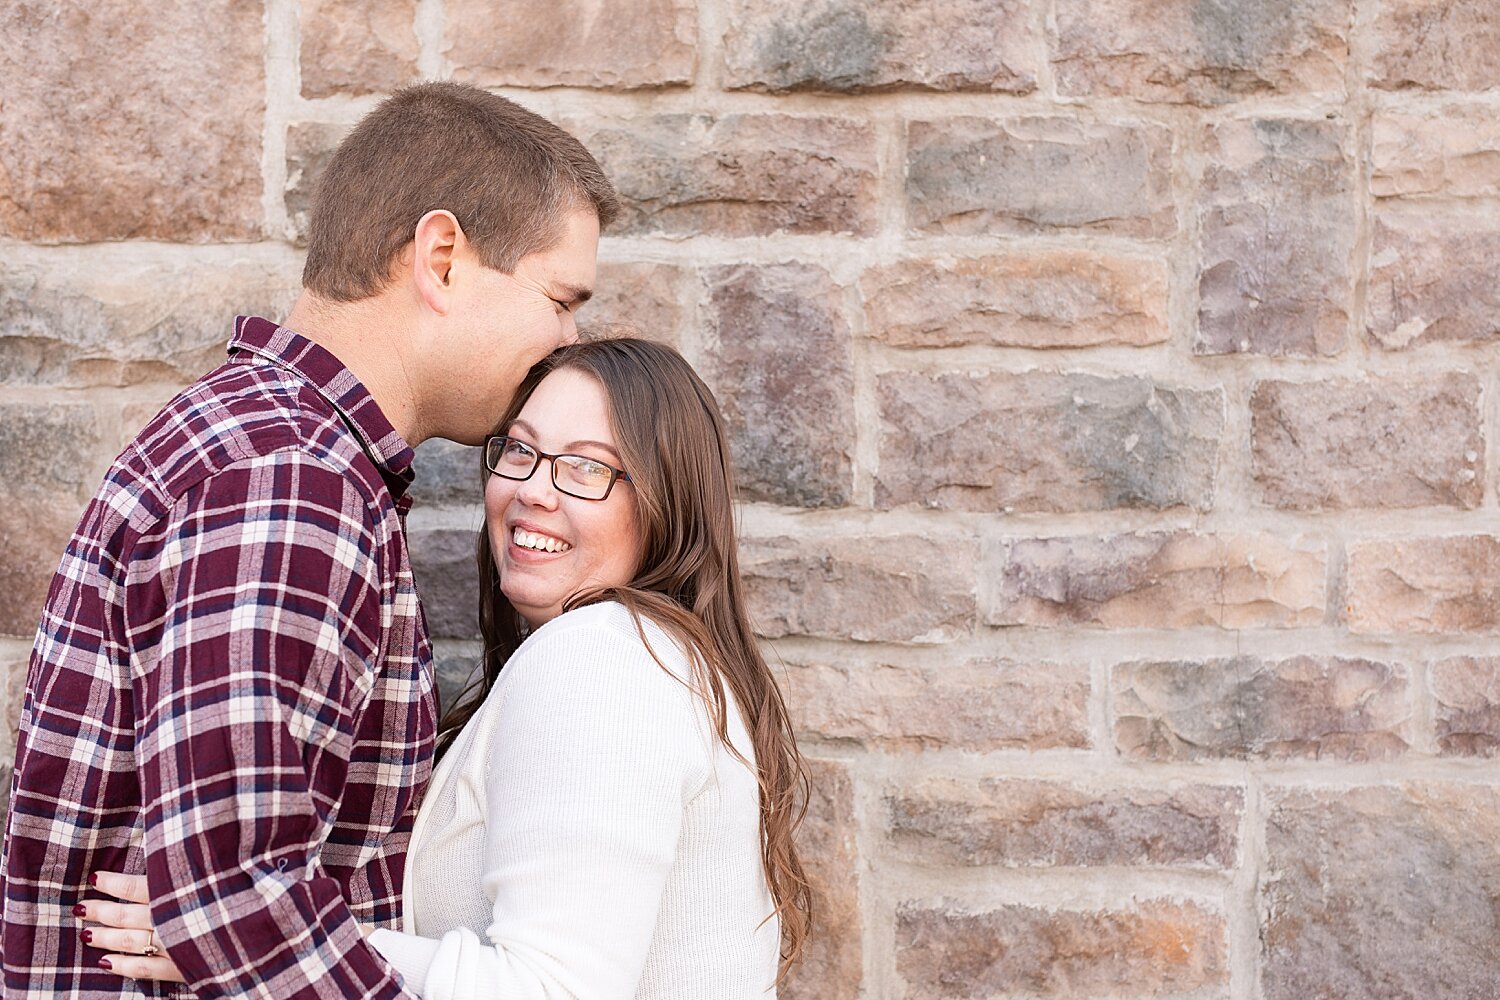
0,247 -> 300,385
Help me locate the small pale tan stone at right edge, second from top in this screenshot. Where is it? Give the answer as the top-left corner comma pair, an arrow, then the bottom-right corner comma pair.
1370,105 -> 1500,199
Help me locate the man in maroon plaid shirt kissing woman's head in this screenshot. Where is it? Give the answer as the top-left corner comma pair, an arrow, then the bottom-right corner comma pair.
0,84 -> 618,1000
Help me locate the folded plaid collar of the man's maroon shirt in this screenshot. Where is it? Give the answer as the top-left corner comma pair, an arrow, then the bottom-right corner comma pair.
230,316 -> 416,511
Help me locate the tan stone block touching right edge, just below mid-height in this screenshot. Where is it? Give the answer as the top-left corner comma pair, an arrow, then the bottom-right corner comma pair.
1347,535 -> 1500,633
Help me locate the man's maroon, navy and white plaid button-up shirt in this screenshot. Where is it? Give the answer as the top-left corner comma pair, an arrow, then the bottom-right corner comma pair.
0,318 -> 435,1000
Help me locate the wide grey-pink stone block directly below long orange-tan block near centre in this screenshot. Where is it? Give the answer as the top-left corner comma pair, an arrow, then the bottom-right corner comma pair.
875,372 -> 1224,513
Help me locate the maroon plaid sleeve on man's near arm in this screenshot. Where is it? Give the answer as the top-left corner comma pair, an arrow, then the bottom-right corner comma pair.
126,450 -> 410,1000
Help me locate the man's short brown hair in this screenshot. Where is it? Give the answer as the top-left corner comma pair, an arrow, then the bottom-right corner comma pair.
302,82 -> 620,301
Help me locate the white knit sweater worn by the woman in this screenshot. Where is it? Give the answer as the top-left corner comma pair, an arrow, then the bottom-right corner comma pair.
371,603 -> 780,1000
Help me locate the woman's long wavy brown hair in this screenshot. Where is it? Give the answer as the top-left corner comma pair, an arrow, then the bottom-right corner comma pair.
438,339 -> 812,982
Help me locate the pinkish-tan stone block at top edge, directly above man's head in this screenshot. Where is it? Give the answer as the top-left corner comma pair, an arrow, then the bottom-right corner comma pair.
447,0 -> 698,87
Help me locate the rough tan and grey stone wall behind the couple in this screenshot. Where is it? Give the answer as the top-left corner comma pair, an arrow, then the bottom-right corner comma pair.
0,0 -> 1500,1000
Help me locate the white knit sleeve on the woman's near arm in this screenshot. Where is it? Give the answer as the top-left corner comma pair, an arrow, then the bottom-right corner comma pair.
371,621 -> 713,1000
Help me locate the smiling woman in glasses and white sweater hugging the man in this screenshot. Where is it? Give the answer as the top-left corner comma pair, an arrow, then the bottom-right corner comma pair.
77,339 -> 810,1000
